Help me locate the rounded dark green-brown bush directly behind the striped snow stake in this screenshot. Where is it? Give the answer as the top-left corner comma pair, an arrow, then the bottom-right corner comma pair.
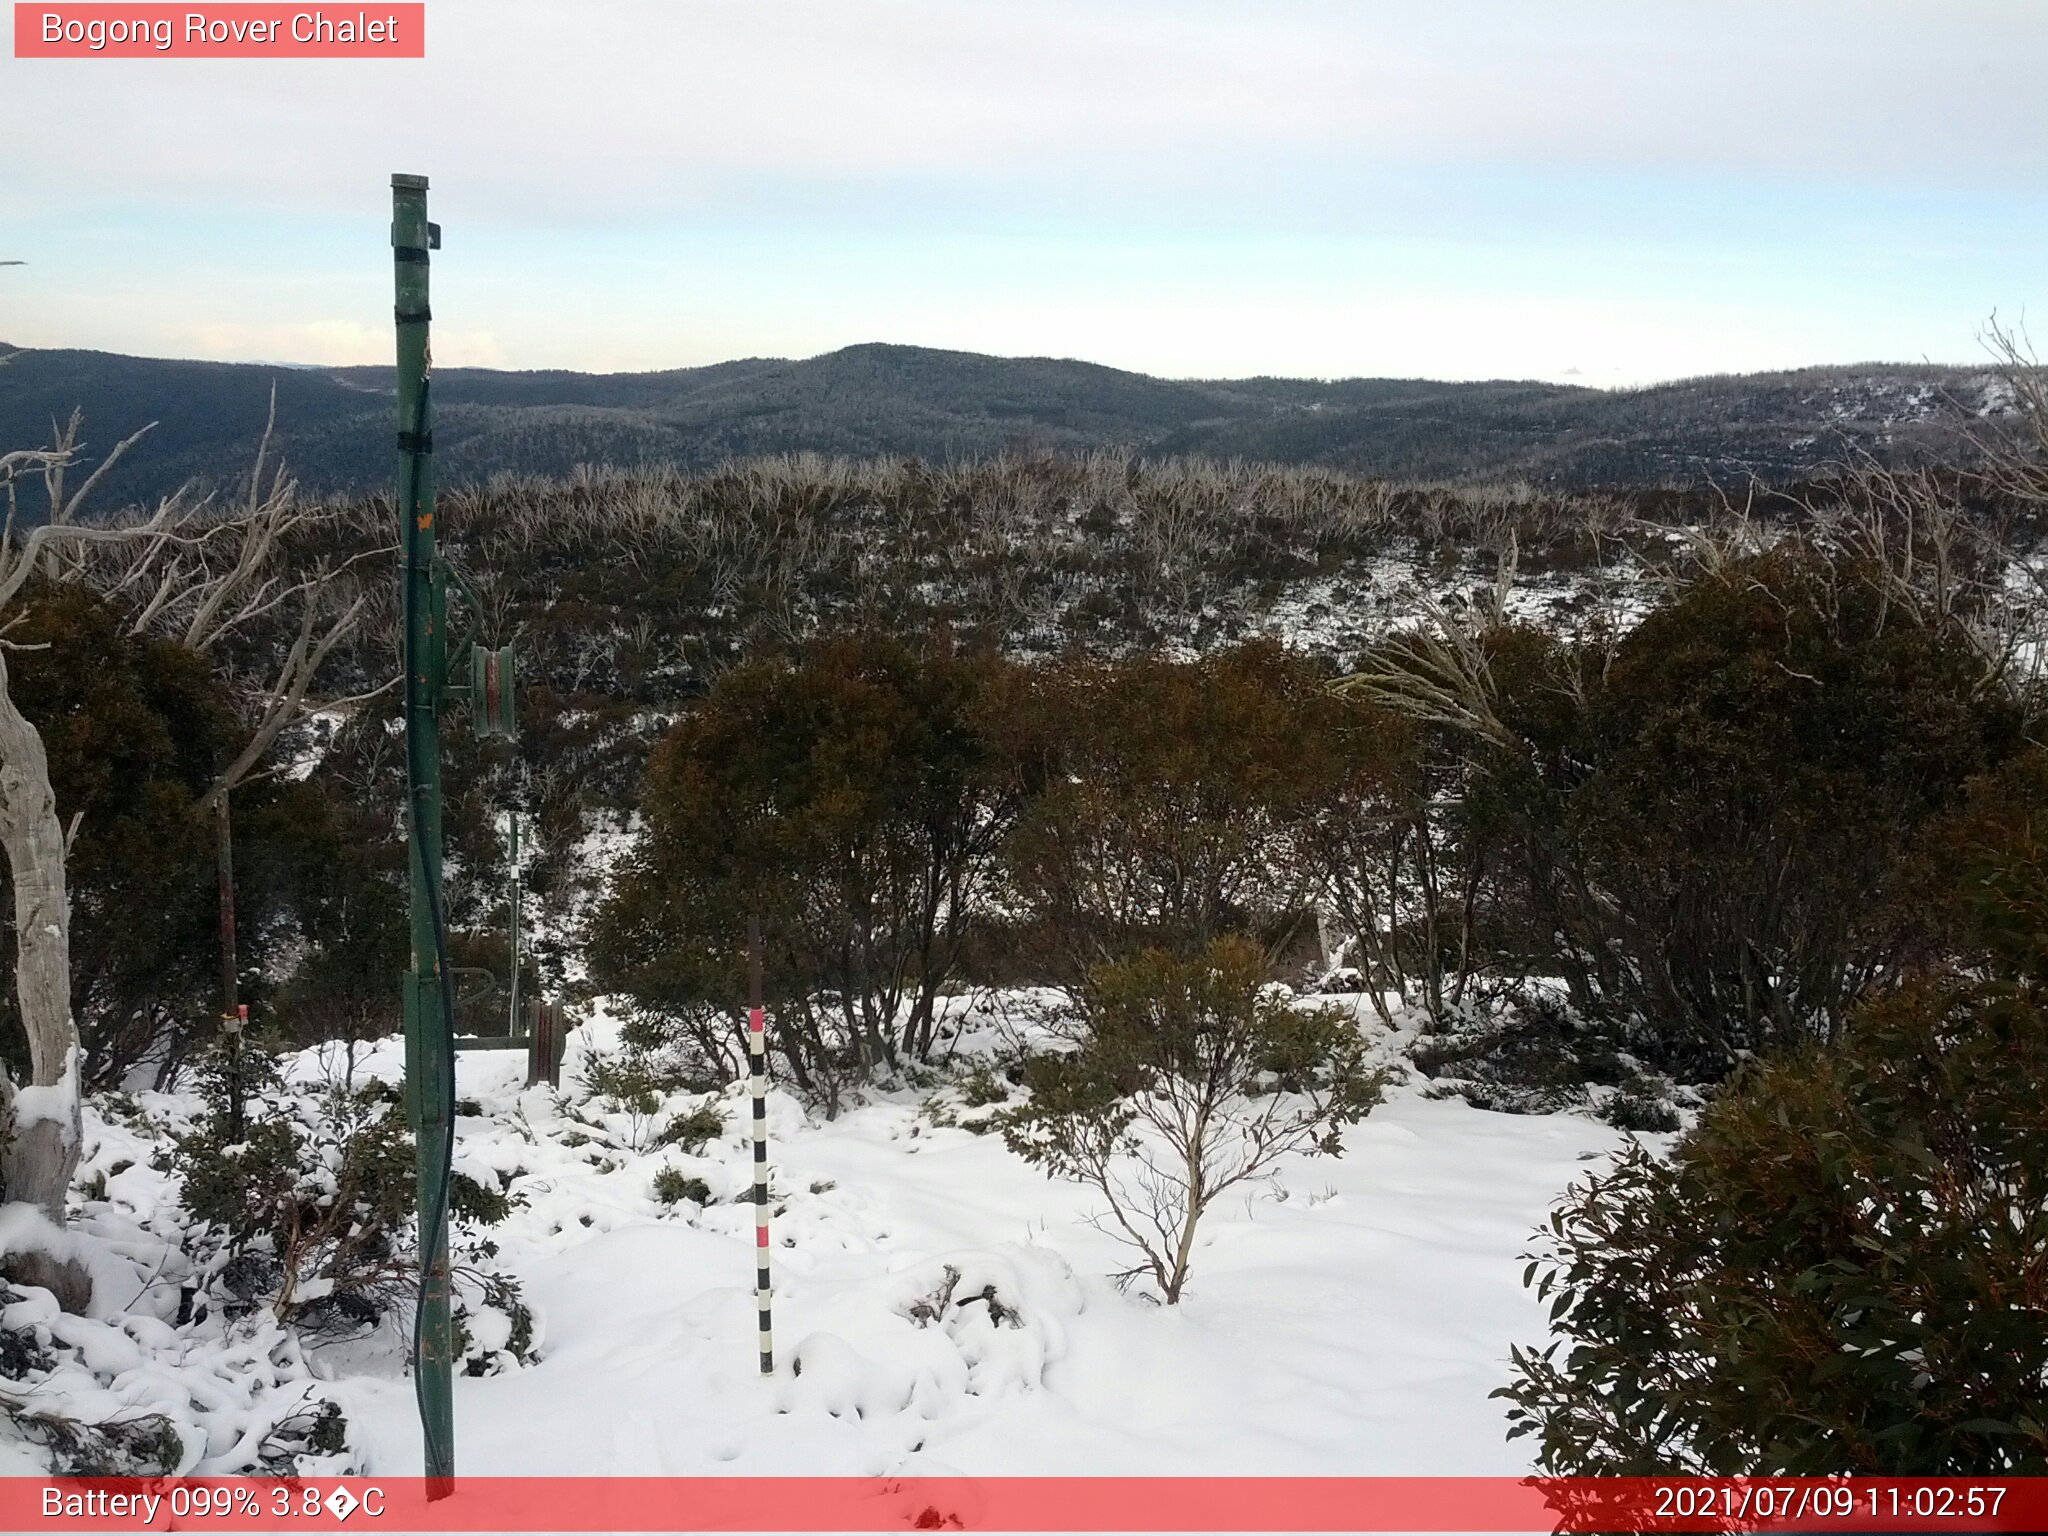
592,633 -> 1018,1104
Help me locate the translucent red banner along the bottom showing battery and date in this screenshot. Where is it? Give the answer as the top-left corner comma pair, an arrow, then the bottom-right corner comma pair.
0,1477 -> 2048,1534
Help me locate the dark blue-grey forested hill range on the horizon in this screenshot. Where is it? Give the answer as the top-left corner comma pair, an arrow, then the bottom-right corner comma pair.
0,344 -> 2003,504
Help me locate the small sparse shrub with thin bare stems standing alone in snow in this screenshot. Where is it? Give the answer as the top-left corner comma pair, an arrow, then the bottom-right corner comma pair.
999,938 -> 1380,1305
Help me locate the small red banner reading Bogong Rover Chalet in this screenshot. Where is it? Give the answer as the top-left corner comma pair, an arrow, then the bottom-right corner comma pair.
14,0 -> 426,59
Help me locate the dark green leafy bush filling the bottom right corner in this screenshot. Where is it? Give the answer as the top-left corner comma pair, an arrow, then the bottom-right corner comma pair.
1501,764 -> 2048,1475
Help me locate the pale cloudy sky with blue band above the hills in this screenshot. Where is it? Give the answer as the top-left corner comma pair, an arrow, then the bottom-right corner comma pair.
0,0 -> 2048,385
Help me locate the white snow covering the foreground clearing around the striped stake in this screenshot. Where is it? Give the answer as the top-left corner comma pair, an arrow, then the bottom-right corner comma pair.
0,993 -> 1626,1475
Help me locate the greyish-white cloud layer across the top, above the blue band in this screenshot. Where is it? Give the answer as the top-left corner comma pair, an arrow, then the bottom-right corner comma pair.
0,0 -> 2048,221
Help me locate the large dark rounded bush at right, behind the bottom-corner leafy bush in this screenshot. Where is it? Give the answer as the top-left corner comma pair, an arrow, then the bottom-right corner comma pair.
1559,551 -> 2019,1055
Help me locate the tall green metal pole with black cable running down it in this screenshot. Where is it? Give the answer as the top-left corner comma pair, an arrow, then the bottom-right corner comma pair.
391,176 -> 455,1499
